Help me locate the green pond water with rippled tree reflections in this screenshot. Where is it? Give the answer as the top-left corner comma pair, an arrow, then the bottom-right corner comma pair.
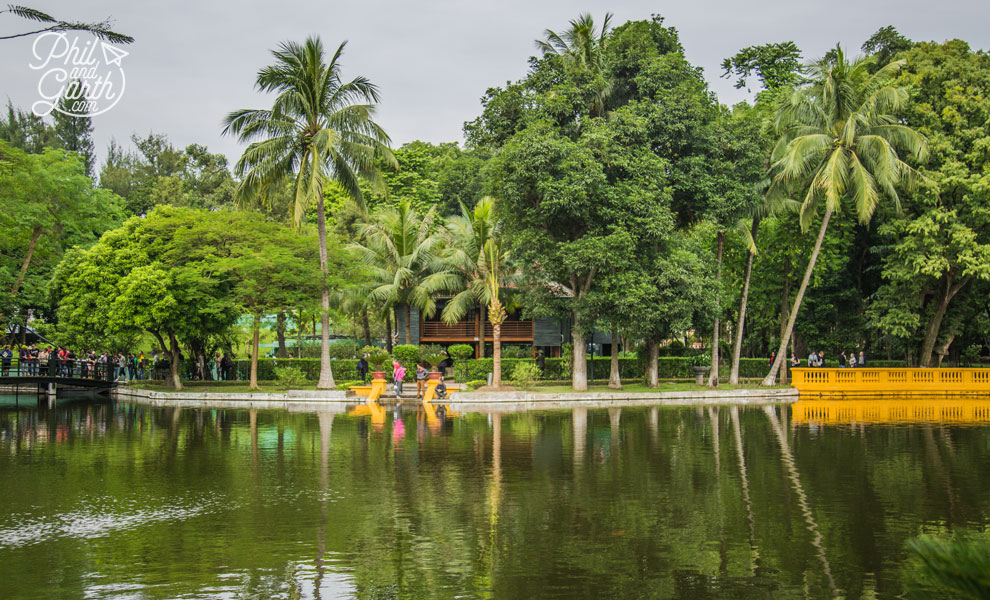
0,398 -> 990,599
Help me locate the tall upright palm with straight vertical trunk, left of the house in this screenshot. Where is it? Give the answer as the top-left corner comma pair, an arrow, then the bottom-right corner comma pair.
223,37 -> 396,389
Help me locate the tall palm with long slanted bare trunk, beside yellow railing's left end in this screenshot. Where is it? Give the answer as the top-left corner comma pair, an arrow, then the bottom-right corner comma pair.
763,46 -> 927,385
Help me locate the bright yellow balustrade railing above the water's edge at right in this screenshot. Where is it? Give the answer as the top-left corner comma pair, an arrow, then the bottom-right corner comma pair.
791,368 -> 990,395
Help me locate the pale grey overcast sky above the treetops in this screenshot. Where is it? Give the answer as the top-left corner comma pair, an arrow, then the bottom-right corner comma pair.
0,0 -> 990,169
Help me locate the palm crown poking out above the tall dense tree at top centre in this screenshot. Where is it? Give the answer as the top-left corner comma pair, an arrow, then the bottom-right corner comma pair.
536,13 -> 612,117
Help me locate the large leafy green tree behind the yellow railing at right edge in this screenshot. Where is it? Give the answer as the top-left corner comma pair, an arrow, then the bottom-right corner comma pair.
870,41 -> 990,366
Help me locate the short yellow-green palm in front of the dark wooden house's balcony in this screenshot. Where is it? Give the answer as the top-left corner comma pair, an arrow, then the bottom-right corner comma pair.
441,196 -> 498,357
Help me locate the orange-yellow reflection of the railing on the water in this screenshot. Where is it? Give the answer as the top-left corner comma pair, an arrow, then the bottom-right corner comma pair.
791,398 -> 990,425
